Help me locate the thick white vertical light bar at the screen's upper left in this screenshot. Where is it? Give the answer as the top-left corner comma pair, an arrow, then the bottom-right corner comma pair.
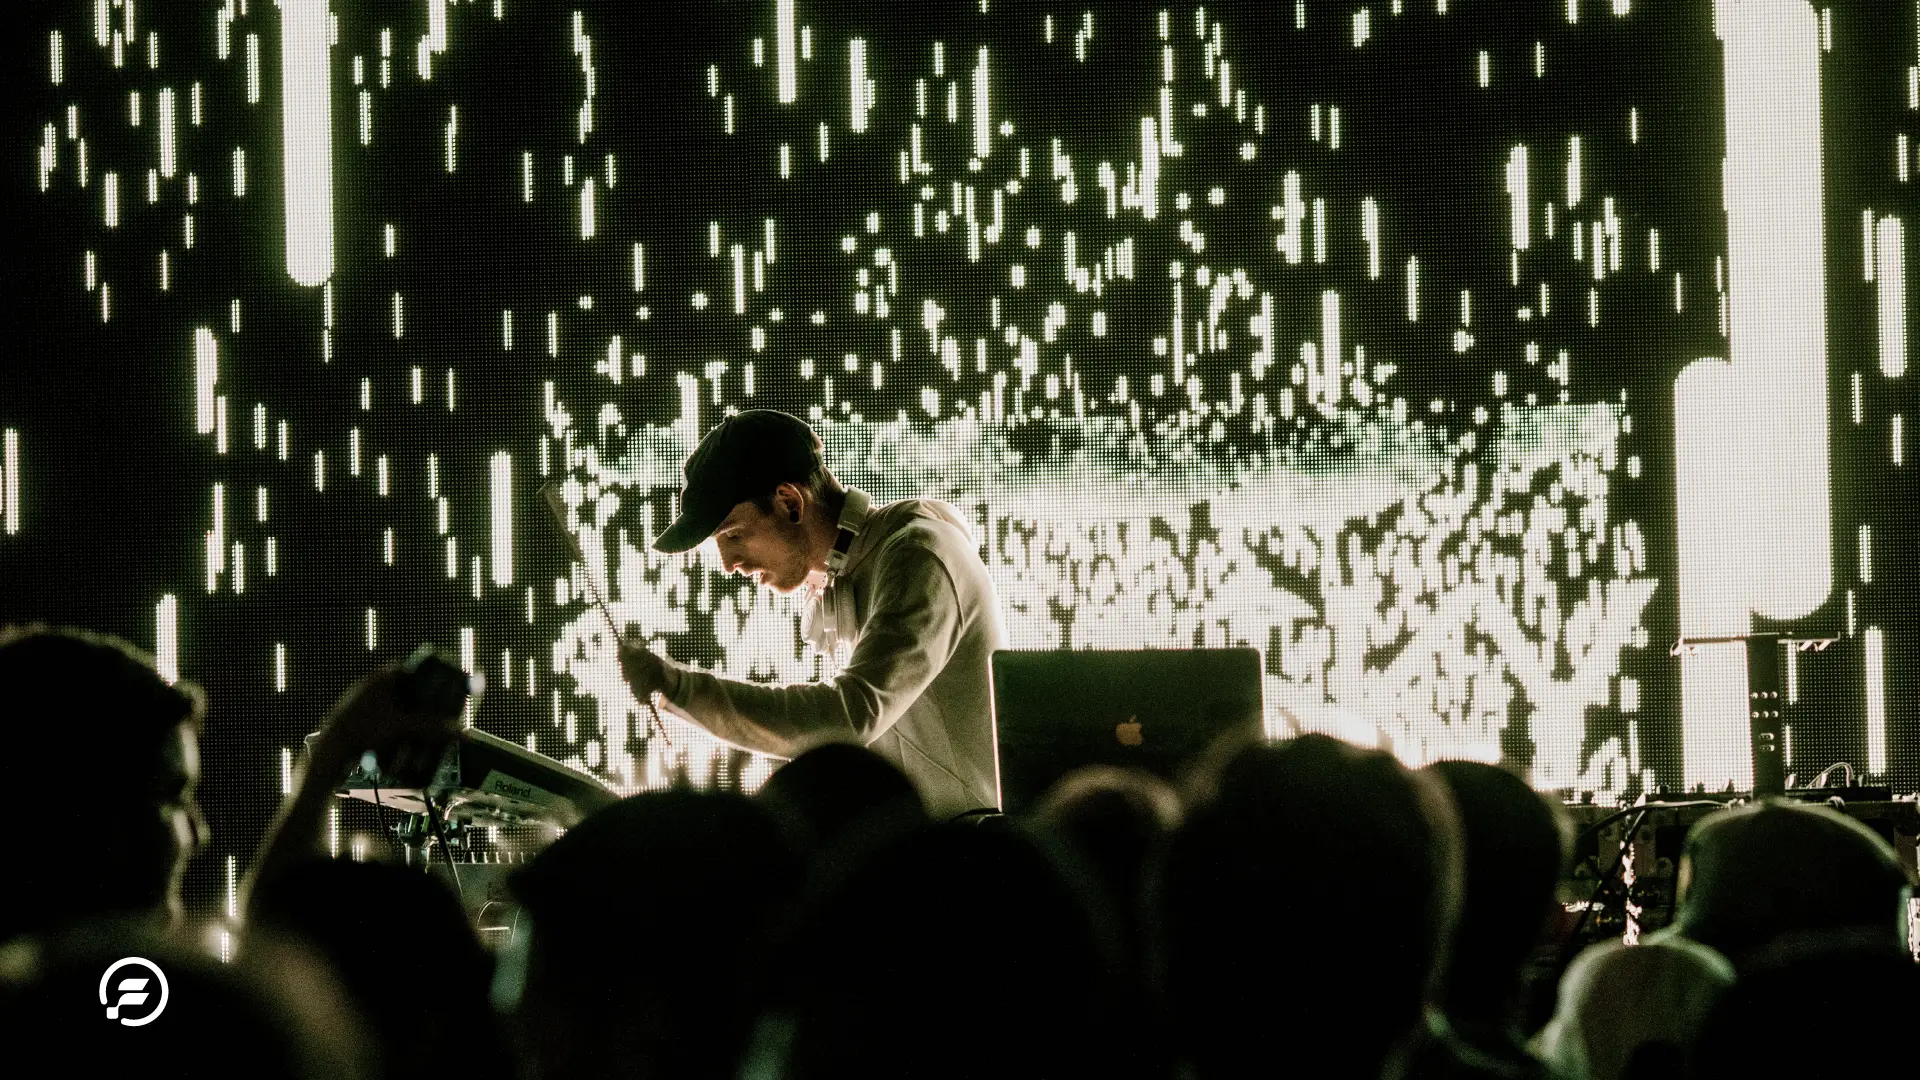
280,0 -> 332,286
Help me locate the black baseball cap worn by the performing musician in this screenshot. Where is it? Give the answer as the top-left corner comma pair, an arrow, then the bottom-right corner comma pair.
653,409 -> 826,553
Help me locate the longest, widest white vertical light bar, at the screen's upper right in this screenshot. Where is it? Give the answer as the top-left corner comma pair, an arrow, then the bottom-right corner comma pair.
1715,0 -> 1834,619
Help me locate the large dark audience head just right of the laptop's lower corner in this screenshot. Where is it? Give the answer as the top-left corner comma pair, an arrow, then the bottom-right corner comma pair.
1154,736 -> 1459,1078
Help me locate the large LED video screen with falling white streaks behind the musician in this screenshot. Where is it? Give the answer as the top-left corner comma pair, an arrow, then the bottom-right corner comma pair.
0,0 -> 1920,915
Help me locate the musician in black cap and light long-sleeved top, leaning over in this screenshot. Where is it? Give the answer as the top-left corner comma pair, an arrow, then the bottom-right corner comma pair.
620,409 -> 1002,819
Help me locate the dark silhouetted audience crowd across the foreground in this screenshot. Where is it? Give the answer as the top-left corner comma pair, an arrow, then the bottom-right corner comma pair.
0,626 -> 1920,1080
